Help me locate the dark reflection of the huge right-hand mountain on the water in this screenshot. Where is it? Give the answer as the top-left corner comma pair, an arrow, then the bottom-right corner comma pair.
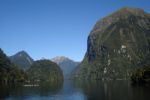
75,81 -> 150,100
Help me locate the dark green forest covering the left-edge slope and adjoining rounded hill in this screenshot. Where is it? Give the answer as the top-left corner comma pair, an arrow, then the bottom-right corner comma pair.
0,49 -> 63,84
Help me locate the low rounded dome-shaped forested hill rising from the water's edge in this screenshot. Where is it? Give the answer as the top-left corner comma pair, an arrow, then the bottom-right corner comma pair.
27,60 -> 63,82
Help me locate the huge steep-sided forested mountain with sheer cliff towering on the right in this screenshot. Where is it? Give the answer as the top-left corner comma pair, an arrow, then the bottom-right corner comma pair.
73,7 -> 150,79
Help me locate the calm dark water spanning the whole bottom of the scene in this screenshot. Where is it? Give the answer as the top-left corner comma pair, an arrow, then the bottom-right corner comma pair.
0,80 -> 150,100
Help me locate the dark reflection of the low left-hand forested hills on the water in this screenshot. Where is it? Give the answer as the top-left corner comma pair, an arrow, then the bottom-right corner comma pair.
0,83 -> 63,100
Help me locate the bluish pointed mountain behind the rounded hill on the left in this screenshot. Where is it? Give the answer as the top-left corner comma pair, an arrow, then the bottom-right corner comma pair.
10,51 -> 34,70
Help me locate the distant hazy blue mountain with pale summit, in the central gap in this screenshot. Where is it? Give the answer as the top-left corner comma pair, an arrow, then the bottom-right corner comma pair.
51,56 -> 79,77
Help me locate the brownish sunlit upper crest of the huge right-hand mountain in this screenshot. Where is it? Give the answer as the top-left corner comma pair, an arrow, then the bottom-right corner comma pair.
91,7 -> 150,34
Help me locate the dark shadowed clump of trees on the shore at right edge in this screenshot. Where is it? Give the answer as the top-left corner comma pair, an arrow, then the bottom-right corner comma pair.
131,66 -> 150,84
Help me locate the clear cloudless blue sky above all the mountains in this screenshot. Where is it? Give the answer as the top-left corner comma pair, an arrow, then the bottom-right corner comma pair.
0,0 -> 150,61
